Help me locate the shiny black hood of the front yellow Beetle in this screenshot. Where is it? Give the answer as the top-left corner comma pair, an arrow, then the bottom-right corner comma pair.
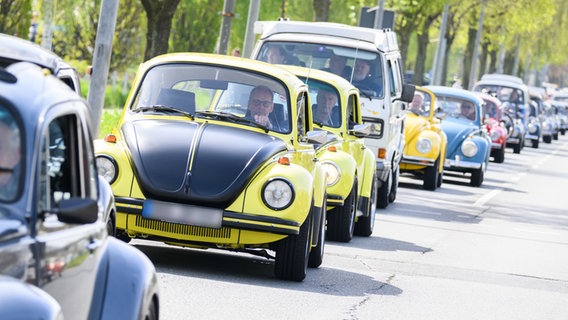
122,119 -> 286,208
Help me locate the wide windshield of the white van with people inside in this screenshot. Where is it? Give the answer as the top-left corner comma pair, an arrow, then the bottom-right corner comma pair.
256,41 -> 384,97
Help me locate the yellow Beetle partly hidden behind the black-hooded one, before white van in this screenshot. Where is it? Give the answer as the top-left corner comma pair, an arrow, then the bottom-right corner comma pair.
282,65 -> 377,242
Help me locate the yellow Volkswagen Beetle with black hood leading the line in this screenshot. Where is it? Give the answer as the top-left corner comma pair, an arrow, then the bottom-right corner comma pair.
96,53 -> 326,281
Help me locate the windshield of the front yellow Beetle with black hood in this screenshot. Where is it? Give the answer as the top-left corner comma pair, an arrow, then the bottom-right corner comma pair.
131,64 -> 291,133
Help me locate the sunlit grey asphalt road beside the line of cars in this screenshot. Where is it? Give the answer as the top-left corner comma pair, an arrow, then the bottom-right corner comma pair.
132,136 -> 568,320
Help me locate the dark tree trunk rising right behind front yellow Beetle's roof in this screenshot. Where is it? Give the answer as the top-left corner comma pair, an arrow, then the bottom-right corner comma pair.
141,0 -> 180,61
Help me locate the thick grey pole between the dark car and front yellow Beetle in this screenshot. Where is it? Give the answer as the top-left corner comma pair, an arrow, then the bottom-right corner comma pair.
87,0 -> 118,139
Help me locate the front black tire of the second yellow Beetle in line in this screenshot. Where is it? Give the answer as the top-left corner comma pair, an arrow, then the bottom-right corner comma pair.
326,179 -> 357,242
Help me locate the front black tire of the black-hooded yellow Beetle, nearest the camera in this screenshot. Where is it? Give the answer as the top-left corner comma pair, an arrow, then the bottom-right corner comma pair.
274,215 -> 312,281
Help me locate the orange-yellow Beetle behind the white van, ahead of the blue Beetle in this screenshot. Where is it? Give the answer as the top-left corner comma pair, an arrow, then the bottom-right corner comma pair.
400,86 -> 448,190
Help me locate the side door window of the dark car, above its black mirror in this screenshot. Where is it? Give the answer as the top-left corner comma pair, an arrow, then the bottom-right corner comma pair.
38,110 -> 97,230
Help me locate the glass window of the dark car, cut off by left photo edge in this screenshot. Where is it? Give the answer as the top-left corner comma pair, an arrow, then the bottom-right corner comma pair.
0,105 -> 25,202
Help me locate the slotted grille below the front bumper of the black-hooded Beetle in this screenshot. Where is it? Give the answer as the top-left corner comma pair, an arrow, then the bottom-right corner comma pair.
136,216 -> 231,239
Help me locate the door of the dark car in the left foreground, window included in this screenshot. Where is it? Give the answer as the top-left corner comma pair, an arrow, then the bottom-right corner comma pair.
34,109 -> 105,319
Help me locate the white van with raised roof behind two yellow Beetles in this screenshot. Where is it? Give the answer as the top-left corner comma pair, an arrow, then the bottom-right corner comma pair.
252,21 -> 414,208
